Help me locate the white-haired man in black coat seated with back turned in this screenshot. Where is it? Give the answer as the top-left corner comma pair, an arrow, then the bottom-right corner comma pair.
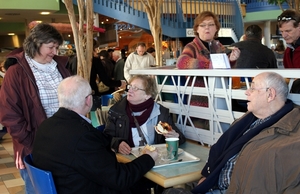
32,76 -> 158,194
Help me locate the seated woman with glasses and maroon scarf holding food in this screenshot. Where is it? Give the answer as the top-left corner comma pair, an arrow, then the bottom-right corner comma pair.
104,75 -> 186,194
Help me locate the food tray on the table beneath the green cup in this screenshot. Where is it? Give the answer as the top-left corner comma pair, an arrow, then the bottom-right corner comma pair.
131,144 -> 200,168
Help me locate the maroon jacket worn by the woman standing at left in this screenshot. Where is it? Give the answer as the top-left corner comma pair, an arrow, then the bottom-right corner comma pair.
0,49 -> 70,168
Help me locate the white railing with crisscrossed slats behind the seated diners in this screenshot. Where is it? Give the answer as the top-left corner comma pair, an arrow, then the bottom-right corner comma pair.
130,66 -> 300,145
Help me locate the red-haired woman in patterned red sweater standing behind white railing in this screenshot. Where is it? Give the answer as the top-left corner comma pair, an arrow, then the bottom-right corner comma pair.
176,11 -> 240,129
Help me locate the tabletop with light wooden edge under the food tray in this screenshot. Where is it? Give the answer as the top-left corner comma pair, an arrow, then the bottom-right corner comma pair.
117,141 -> 209,188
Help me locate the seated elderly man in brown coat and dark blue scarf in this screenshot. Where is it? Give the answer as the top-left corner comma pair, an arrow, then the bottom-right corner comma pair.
165,72 -> 300,194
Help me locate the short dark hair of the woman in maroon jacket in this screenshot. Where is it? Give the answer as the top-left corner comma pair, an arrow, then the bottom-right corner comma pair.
23,23 -> 63,58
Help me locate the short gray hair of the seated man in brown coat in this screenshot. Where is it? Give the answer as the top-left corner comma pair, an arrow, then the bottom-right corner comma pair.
265,72 -> 289,102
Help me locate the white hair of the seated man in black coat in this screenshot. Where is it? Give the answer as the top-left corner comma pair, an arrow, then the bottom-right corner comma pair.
57,75 -> 92,110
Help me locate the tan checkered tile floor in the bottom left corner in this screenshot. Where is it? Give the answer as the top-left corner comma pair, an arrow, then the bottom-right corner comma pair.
0,134 -> 25,194
